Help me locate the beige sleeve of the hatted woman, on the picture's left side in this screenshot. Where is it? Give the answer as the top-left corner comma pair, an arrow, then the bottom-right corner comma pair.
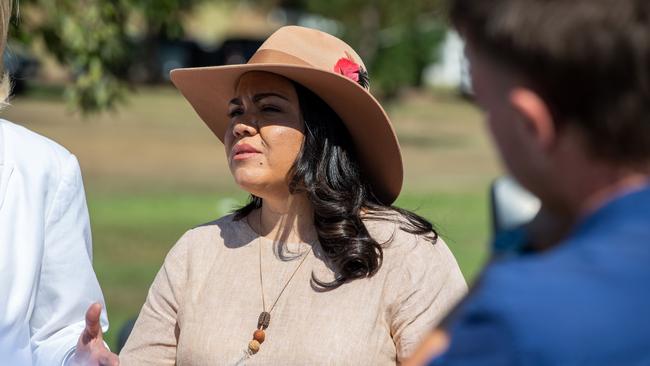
120,234 -> 189,366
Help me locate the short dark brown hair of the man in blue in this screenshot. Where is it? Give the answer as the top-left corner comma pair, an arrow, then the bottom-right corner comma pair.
450,0 -> 650,163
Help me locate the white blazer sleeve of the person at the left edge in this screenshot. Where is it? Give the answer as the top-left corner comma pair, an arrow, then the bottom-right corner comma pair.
29,154 -> 108,366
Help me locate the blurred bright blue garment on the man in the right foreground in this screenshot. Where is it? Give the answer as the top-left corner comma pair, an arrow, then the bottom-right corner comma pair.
430,186 -> 650,366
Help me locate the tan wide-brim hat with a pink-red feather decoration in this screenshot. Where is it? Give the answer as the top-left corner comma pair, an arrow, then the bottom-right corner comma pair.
171,26 -> 403,204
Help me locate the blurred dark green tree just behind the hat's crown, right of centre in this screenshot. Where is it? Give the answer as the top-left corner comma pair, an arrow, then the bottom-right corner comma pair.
254,0 -> 446,97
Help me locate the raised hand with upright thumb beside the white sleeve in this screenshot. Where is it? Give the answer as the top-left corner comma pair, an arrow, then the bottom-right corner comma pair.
69,303 -> 120,366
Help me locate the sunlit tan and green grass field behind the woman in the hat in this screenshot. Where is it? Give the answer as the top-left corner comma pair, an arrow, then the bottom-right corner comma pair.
3,88 -> 499,347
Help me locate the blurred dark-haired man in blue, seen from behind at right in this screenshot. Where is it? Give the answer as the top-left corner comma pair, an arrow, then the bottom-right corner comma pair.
404,0 -> 650,366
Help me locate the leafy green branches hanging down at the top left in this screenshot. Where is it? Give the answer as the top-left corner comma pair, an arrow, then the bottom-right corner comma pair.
11,0 -> 203,113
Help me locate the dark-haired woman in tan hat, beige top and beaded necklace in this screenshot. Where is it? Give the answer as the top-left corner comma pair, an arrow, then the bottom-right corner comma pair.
120,27 -> 466,366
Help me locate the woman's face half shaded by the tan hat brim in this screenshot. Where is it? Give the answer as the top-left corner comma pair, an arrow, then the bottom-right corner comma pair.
224,71 -> 305,198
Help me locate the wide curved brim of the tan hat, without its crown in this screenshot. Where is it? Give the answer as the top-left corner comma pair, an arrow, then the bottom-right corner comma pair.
171,64 -> 403,204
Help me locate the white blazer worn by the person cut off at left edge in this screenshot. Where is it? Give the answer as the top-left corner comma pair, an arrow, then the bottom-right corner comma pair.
0,120 -> 108,366
